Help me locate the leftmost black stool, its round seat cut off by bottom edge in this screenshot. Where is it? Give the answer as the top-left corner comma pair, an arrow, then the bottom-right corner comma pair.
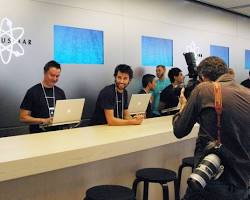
84,185 -> 135,200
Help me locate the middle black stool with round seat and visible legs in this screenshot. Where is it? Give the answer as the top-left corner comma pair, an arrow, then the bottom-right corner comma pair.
133,168 -> 179,200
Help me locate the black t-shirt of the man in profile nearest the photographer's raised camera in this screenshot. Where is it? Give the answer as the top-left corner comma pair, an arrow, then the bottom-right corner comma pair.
160,84 -> 181,109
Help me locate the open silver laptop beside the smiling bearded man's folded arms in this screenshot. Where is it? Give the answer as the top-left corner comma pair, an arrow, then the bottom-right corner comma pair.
128,94 -> 151,115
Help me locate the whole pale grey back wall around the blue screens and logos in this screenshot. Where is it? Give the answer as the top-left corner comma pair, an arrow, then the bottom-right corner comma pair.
0,0 -> 250,131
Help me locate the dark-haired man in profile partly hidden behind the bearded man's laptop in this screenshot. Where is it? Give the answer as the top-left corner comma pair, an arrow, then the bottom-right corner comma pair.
139,74 -> 158,118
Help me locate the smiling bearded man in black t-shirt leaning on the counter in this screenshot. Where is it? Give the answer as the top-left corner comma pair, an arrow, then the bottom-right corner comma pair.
90,64 -> 143,126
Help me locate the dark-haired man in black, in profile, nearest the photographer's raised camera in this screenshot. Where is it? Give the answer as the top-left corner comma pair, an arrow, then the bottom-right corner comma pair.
159,67 -> 184,114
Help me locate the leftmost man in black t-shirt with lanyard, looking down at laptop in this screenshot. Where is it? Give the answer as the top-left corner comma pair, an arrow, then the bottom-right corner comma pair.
20,61 -> 66,133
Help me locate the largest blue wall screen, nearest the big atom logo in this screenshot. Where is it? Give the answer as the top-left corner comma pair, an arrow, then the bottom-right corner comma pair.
54,25 -> 104,64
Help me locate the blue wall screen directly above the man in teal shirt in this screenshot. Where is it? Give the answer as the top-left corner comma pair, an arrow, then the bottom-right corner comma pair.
141,36 -> 173,66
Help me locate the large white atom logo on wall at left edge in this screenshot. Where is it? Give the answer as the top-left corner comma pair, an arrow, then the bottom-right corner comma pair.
0,17 -> 24,64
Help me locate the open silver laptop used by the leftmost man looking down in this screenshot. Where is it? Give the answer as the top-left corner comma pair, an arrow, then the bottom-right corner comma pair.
49,98 -> 85,126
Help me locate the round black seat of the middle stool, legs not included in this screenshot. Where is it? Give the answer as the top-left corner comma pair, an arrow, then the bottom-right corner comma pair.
136,168 -> 177,184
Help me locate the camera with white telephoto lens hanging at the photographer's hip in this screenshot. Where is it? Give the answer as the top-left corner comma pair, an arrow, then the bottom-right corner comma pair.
187,141 -> 224,191
